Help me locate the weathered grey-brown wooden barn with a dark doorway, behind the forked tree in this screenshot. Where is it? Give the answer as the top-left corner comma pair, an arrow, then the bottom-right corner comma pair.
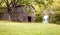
0,5 -> 35,22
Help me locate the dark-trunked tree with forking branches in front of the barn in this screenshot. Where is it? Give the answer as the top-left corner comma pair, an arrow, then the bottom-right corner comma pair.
0,0 -> 17,20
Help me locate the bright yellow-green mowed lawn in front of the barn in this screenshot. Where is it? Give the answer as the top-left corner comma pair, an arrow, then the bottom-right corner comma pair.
0,21 -> 60,35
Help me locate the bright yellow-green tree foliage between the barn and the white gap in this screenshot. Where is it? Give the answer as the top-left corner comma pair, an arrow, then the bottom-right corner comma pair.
35,0 -> 53,22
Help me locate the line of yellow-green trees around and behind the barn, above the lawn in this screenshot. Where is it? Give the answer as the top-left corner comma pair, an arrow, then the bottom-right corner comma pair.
0,0 -> 60,23
